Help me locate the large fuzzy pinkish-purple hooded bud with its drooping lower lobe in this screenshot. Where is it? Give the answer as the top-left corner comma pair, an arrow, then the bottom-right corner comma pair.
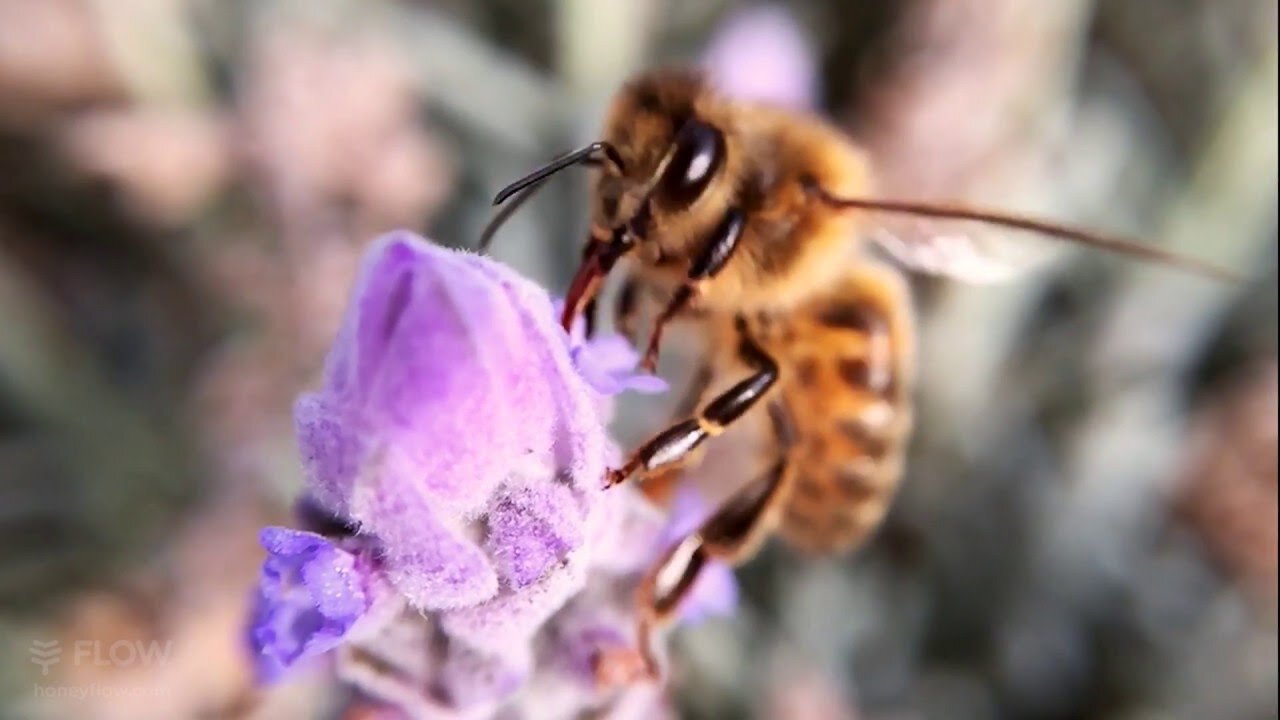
296,233 -> 619,609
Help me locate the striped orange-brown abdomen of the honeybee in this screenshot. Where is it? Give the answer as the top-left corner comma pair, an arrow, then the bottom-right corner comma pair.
769,264 -> 914,552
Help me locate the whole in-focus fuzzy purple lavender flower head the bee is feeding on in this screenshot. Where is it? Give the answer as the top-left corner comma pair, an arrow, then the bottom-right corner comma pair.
251,232 -> 733,717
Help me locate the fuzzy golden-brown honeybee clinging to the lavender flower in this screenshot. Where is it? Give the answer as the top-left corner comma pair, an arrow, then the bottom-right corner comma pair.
481,68 -> 1229,671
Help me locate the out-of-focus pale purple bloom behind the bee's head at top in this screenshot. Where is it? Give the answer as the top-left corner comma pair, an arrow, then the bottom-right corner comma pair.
703,5 -> 817,109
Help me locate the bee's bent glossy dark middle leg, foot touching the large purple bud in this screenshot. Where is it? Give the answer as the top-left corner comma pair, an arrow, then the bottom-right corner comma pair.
605,320 -> 778,487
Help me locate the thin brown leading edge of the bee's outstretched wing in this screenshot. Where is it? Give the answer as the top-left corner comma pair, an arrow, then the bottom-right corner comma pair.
804,178 -> 1243,282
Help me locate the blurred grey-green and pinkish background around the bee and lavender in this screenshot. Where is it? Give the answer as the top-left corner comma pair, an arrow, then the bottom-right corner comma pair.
0,0 -> 1277,720
